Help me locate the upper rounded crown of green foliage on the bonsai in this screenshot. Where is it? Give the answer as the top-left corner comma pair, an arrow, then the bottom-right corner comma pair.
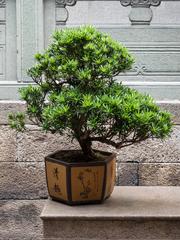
28,26 -> 134,92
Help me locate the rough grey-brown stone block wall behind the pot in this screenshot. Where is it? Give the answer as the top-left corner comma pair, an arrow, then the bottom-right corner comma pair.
0,101 -> 180,240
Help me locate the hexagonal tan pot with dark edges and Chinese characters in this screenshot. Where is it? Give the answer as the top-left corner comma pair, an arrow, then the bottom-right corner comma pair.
45,150 -> 116,205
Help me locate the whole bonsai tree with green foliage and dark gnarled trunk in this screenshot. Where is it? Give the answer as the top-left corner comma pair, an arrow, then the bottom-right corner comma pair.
9,26 -> 172,161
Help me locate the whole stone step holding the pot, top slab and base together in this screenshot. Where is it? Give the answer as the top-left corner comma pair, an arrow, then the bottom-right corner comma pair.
41,187 -> 180,240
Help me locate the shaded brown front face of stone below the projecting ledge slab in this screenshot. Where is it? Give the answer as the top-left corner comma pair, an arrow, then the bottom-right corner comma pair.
41,220 -> 180,240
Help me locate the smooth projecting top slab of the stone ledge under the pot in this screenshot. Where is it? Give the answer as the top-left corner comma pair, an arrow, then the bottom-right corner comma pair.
41,187 -> 180,221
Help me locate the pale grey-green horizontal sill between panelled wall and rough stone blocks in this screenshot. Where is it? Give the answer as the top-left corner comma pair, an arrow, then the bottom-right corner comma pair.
0,81 -> 180,101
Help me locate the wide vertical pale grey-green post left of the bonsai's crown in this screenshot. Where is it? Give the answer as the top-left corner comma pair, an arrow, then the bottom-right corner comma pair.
16,0 -> 44,82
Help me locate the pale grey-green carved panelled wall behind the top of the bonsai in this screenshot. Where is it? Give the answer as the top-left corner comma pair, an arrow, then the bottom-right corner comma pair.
0,0 -> 180,100
